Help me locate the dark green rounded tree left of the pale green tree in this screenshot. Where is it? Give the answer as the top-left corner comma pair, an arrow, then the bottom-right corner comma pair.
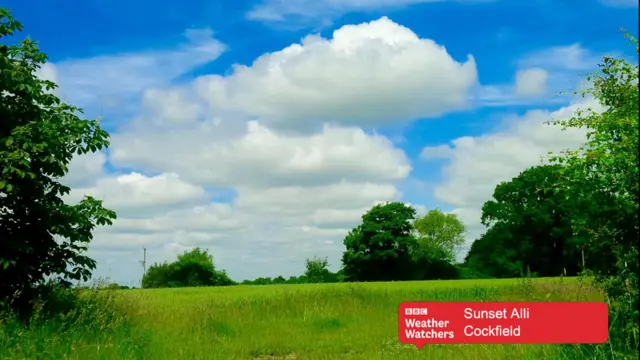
342,202 -> 416,281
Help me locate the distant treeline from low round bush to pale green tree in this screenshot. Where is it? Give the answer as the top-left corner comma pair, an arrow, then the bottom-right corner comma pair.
142,207 -> 465,288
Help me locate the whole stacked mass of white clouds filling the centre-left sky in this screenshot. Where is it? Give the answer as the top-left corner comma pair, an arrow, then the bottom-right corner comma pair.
47,18 -> 464,283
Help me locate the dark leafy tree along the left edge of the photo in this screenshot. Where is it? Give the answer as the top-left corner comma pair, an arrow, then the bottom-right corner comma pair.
0,9 -> 116,314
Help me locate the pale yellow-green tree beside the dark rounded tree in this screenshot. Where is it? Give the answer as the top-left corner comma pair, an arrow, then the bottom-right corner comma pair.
413,210 -> 466,263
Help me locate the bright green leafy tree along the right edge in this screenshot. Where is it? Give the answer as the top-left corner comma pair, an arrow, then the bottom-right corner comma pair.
551,37 -> 640,354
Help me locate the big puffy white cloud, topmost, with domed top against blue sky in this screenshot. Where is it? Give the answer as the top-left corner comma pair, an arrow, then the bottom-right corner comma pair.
196,17 -> 477,130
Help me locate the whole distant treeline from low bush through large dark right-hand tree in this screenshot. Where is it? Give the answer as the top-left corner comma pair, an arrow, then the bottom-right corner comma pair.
142,173 -> 604,288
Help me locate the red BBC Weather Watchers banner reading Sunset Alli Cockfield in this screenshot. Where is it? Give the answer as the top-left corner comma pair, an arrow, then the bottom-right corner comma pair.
398,302 -> 609,348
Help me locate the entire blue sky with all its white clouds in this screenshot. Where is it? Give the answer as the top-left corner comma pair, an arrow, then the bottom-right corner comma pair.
6,0 -> 638,284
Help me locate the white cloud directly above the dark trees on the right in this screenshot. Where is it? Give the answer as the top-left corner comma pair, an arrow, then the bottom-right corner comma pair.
423,101 -> 601,255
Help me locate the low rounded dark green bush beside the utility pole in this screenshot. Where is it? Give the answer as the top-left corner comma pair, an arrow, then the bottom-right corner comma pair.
142,248 -> 235,288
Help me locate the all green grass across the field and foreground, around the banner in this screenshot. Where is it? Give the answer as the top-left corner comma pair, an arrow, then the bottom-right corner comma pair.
0,278 -> 628,360
